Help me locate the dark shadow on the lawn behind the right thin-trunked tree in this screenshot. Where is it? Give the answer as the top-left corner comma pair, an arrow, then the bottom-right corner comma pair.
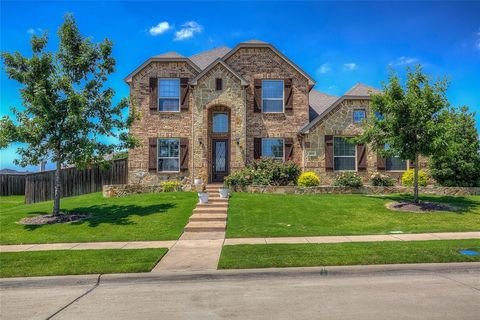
369,193 -> 480,214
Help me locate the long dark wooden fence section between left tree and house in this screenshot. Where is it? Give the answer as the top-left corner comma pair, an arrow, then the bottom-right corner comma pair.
22,159 -> 128,203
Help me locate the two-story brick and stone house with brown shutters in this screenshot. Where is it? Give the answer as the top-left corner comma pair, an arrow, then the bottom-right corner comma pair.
125,41 -> 420,184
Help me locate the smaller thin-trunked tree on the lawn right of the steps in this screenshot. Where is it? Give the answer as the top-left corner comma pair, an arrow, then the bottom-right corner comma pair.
359,66 -> 449,202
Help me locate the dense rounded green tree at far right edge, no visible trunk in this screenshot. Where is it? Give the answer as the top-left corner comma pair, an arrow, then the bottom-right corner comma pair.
429,107 -> 480,187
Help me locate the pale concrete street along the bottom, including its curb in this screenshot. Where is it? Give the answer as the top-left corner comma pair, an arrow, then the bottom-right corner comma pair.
0,263 -> 480,320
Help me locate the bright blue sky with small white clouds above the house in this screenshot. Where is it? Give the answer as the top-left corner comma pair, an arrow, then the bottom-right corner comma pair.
0,1 -> 480,170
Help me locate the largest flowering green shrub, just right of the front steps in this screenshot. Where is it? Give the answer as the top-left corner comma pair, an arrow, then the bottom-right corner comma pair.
224,159 -> 301,187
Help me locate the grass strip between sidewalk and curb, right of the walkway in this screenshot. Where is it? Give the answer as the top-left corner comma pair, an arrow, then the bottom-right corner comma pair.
218,240 -> 480,269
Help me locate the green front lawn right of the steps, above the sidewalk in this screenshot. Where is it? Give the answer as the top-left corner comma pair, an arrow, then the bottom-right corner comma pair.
227,193 -> 480,238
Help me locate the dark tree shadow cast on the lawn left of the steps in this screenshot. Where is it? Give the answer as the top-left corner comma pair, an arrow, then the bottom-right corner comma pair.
24,203 -> 177,231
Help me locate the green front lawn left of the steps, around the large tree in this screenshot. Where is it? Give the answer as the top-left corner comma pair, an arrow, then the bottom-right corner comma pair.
0,192 -> 197,244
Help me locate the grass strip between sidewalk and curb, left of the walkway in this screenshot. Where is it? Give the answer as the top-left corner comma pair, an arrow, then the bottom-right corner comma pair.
0,248 -> 167,278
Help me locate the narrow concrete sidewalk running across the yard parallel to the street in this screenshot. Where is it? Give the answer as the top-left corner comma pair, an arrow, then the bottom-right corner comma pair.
0,231 -> 480,252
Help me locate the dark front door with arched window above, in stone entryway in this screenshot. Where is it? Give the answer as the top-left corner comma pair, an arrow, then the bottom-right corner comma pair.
208,106 -> 231,182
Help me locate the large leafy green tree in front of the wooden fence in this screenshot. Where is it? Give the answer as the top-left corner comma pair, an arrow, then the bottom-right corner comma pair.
0,14 -> 137,215
